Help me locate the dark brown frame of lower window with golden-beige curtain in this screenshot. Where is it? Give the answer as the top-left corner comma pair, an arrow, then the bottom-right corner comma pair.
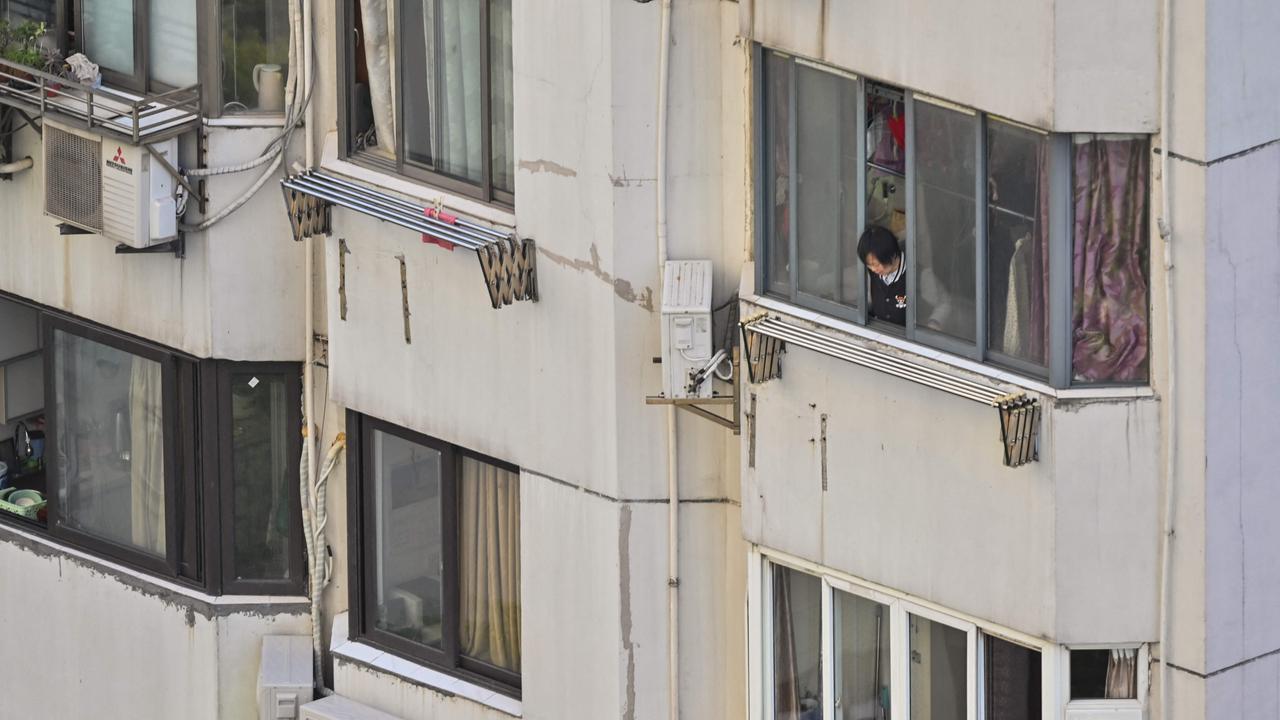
347,409 -> 522,700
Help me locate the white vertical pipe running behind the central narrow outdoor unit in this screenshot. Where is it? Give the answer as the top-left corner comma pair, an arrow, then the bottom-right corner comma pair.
654,0 -> 680,720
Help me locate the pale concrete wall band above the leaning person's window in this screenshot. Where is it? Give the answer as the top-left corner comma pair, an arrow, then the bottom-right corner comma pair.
740,0 -> 1158,132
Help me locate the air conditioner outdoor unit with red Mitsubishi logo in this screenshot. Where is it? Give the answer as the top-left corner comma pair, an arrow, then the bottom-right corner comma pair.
44,120 -> 178,249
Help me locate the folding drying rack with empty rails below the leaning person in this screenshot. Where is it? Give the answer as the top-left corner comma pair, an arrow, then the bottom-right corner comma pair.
741,314 -> 1041,468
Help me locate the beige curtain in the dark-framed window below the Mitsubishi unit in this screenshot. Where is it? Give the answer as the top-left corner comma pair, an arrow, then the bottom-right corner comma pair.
129,357 -> 165,555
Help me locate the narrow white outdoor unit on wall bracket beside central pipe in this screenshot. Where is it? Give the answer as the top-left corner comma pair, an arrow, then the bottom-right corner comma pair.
662,260 -> 714,397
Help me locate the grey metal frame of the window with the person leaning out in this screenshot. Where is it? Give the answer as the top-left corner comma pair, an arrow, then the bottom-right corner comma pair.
751,44 -> 1152,389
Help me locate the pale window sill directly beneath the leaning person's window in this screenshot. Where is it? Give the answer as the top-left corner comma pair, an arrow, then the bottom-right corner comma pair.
742,293 -> 1155,400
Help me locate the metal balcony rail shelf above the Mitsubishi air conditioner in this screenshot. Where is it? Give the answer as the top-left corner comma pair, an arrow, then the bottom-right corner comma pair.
0,59 -> 201,145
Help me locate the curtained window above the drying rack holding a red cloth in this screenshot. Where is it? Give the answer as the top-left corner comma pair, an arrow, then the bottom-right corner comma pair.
343,0 -> 515,205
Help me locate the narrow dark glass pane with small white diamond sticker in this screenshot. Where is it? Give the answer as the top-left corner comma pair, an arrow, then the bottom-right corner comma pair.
230,373 -> 297,580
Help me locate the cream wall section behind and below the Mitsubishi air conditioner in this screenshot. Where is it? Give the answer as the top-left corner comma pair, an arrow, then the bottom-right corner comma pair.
0,122 -> 305,360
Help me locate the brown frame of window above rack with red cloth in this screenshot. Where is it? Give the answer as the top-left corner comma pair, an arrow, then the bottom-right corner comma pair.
335,0 -> 516,210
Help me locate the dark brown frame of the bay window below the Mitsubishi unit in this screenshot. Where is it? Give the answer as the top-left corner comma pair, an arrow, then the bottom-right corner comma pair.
0,291 -> 306,596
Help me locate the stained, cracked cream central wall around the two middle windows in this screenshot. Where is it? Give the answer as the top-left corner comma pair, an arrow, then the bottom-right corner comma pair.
308,0 -> 748,720
